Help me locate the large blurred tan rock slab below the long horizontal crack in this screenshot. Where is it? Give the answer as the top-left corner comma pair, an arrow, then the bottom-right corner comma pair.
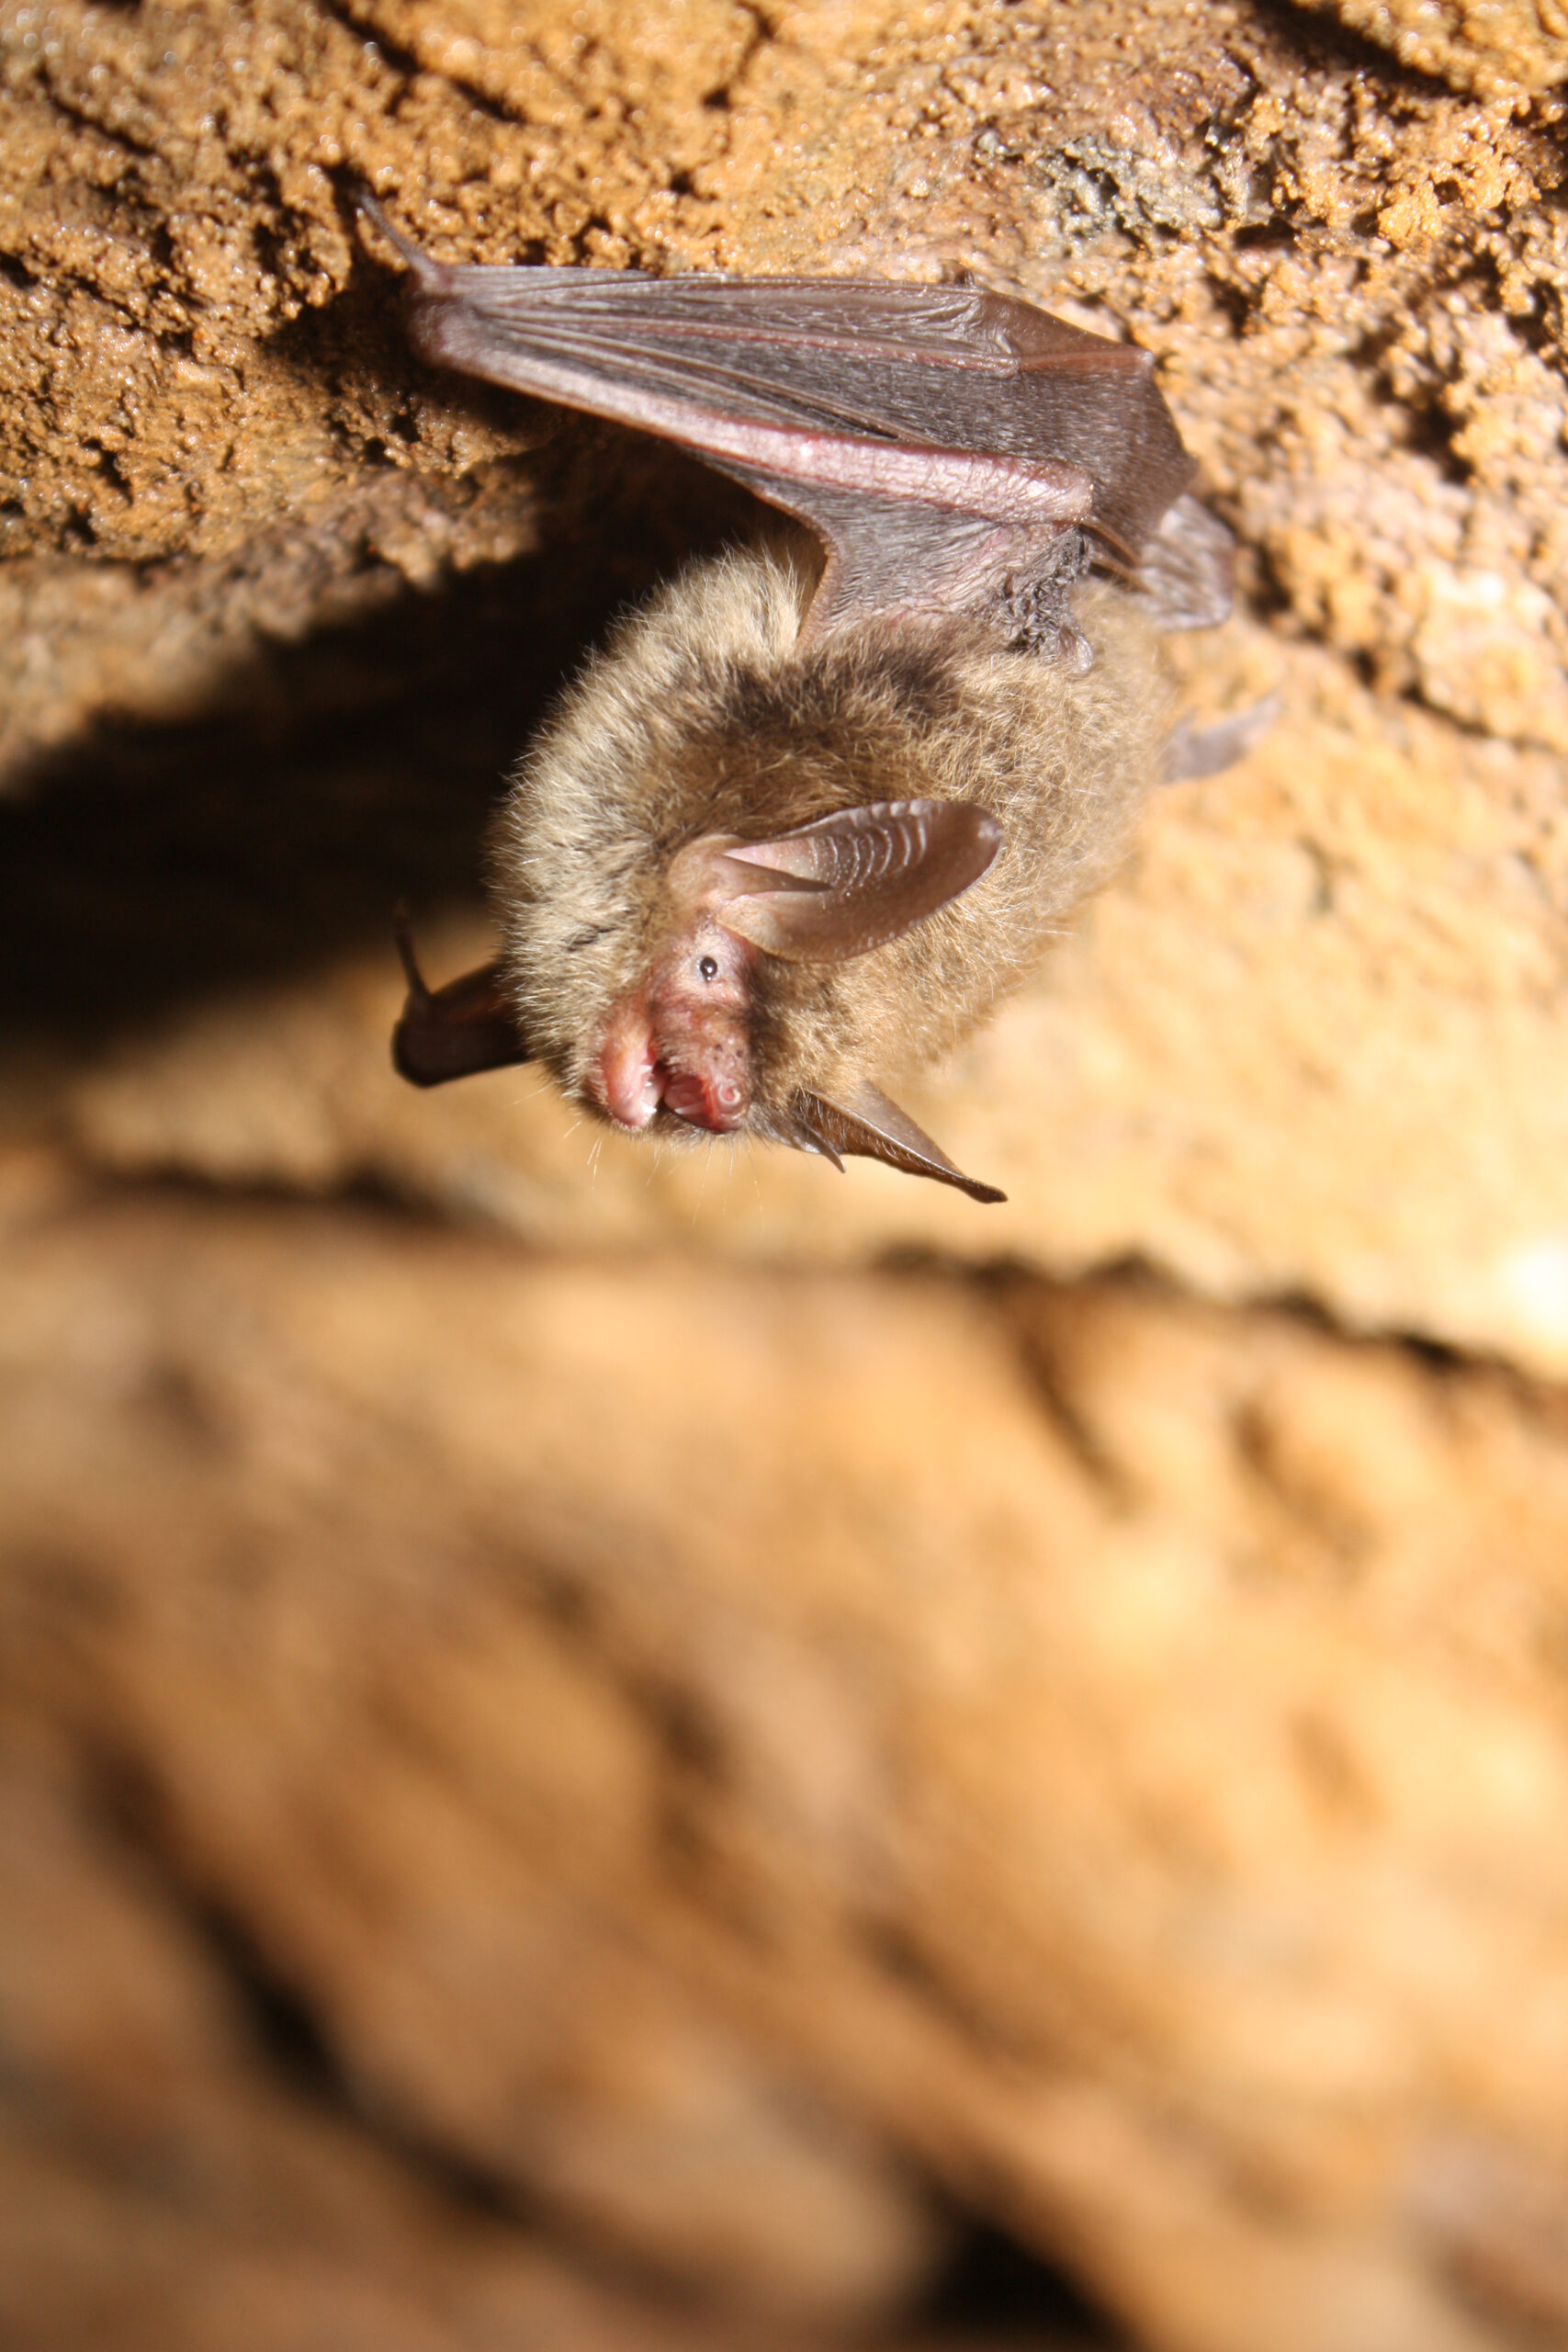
0,1197 -> 1568,2352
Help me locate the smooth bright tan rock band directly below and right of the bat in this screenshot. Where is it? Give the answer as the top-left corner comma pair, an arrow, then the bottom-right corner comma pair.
40,633 -> 1568,1374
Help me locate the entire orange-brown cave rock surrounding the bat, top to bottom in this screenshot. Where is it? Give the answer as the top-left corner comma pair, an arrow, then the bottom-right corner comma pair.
0,0 -> 1568,2352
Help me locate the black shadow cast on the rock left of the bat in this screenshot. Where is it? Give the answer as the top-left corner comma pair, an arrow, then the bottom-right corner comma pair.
0,425 -> 750,1042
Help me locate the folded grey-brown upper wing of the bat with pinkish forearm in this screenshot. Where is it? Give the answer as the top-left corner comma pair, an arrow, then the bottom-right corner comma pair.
362,200 -> 1192,633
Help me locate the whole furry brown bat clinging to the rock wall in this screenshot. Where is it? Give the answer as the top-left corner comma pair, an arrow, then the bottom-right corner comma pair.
362,200 -> 1258,1202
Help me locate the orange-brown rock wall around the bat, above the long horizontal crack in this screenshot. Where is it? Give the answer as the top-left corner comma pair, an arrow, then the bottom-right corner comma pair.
0,0 -> 1568,1374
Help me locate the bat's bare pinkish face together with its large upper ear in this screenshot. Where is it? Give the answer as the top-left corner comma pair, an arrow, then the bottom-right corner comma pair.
585,799 -> 1001,1141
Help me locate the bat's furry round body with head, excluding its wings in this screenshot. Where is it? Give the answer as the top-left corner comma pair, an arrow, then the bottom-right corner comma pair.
493,540 -> 1164,1194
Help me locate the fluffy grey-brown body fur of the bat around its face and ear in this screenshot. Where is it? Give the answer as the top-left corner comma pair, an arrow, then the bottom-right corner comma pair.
493,553 -> 1168,1134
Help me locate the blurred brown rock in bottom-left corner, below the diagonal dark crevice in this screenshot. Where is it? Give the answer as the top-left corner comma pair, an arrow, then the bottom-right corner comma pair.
0,1712 -> 831,2352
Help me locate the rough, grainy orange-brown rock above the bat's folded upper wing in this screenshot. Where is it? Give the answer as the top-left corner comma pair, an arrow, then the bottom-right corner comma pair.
0,0 -> 1568,771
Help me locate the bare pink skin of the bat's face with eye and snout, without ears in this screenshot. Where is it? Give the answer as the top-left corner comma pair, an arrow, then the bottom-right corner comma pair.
588,917 -> 755,1136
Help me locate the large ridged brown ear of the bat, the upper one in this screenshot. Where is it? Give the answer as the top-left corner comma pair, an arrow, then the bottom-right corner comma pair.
715,799 -> 1001,965
